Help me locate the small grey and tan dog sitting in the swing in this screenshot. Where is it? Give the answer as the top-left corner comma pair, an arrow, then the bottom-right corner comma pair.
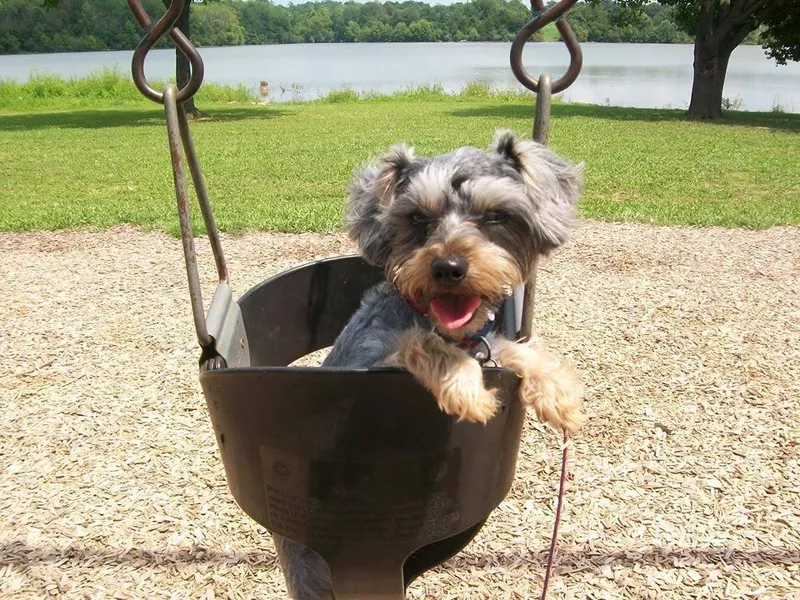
275,130 -> 585,600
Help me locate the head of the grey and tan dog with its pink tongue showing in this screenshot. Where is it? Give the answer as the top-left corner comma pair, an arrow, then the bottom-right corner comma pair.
348,132 -> 581,338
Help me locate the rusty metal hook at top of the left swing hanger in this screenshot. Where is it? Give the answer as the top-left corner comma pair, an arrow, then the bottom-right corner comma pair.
128,0 -> 204,104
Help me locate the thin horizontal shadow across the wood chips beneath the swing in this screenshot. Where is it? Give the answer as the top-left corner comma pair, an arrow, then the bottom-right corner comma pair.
0,540 -> 800,573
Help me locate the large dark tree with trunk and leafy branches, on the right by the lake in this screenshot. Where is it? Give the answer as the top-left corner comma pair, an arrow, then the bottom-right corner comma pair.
620,0 -> 800,120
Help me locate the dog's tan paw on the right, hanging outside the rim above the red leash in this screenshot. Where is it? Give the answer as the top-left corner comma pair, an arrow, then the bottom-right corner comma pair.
522,363 -> 586,435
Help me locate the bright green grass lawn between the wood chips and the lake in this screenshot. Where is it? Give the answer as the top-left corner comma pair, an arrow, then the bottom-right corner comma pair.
0,94 -> 800,233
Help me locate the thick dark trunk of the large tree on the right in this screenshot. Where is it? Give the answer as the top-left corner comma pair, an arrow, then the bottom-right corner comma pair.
689,36 -> 735,120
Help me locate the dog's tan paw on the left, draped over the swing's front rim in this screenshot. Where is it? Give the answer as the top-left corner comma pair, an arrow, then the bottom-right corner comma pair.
436,361 -> 498,425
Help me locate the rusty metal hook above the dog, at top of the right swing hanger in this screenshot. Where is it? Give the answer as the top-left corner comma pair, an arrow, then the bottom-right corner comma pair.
511,0 -> 583,94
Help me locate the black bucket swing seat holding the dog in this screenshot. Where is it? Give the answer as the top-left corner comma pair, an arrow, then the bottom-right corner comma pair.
200,257 -> 524,600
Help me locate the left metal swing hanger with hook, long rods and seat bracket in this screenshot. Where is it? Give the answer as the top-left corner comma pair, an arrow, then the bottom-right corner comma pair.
128,0 -> 249,367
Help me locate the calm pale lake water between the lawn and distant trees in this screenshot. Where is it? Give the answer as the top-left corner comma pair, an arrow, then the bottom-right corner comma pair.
0,42 -> 800,112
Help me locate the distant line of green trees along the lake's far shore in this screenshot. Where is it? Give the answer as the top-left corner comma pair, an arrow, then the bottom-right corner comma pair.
0,0 -> 696,54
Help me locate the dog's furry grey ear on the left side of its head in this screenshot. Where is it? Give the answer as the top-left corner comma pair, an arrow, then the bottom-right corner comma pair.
347,144 -> 414,267
